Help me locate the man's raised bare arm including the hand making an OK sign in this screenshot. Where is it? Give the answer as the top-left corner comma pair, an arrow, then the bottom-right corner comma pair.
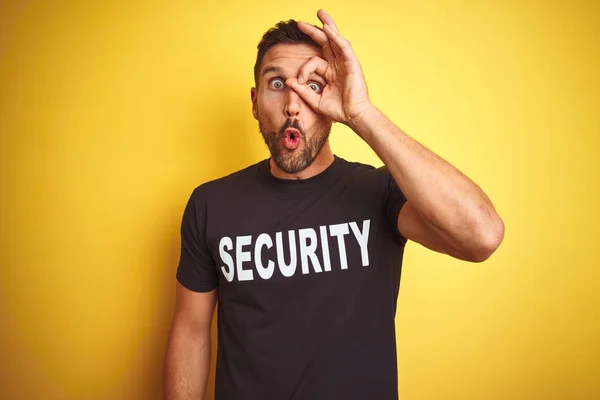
286,10 -> 504,262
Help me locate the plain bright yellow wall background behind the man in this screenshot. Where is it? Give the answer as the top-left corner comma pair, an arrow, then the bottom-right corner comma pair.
0,0 -> 600,400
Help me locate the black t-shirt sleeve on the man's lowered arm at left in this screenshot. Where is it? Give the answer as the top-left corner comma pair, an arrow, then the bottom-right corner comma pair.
177,189 -> 218,292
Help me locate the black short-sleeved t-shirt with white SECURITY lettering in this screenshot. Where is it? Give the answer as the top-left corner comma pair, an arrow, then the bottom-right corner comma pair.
177,156 -> 406,400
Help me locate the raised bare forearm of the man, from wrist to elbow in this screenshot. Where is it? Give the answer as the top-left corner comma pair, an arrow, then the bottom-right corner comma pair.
350,103 -> 502,242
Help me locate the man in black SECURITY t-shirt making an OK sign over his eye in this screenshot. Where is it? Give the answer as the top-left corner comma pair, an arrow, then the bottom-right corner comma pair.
165,10 -> 504,400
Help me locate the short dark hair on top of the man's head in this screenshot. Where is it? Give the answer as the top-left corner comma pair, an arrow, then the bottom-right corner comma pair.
254,19 -> 321,87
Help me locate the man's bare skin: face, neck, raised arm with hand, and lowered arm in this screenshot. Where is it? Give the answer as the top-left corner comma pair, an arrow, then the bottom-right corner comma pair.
164,10 -> 504,400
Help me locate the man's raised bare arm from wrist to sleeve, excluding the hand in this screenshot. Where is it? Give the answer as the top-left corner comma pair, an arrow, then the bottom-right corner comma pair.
353,108 -> 504,262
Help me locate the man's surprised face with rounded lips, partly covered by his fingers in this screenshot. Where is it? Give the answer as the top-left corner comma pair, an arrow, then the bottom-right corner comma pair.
251,44 -> 332,174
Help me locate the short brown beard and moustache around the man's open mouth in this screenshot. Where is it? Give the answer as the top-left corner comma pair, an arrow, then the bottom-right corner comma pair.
258,119 -> 331,174
